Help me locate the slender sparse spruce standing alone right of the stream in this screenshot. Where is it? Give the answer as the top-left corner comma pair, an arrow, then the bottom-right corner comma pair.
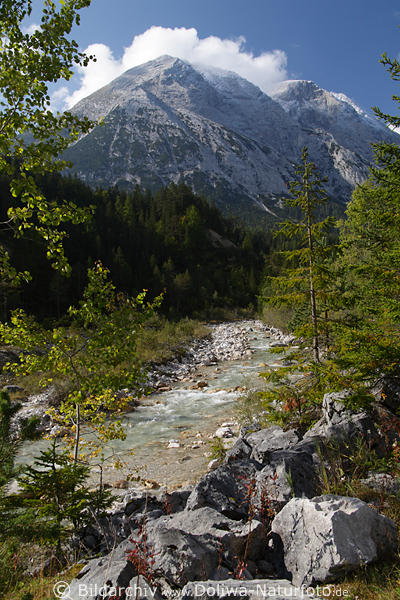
260,148 -> 336,428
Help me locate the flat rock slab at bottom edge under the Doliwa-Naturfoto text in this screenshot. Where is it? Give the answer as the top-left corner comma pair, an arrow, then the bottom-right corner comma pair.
181,579 -> 315,600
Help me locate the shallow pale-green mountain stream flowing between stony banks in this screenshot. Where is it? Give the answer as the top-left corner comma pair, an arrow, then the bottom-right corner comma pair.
18,321 -> 280,489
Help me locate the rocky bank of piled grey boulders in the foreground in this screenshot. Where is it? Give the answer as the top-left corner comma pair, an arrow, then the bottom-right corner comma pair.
63,384 -> 399,600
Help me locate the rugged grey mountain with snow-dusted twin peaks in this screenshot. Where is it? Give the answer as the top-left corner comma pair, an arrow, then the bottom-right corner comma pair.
67,56 -> 400,220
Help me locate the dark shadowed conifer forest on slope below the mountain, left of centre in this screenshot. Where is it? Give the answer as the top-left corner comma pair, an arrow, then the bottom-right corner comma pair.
0,175 -> 277,319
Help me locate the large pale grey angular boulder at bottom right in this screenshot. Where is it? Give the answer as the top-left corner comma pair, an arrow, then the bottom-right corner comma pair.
272,495 -> 397,586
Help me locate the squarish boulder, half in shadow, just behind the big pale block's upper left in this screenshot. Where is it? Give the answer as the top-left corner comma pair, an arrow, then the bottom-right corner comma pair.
256,450 -> 317,515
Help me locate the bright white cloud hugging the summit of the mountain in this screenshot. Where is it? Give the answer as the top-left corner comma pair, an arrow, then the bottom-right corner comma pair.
61,27 -> 287,108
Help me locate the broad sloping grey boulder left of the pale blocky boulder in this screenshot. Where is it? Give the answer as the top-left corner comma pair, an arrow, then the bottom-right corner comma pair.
71,507 -> 269,600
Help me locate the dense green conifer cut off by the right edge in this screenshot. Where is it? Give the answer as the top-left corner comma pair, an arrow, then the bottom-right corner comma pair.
334,54 -> 400,389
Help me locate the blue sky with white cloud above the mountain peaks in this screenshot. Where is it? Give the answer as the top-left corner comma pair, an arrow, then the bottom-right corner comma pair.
32,0 -> 400,113
